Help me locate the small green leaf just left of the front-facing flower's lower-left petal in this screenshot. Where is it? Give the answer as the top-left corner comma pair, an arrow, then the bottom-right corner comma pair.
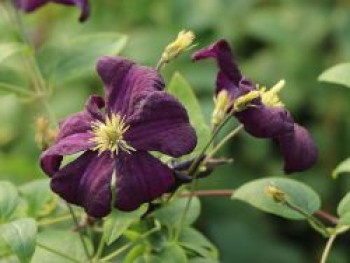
19,179 -> 56,218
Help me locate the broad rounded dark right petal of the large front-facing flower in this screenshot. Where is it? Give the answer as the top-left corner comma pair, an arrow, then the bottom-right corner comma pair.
124,91 -> 197,157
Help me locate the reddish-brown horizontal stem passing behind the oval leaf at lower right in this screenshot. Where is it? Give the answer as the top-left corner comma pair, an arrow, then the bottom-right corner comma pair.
179,189 -> 339,225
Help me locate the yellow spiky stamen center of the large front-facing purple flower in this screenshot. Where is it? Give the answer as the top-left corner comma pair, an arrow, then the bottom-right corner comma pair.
91,113 -> 135,155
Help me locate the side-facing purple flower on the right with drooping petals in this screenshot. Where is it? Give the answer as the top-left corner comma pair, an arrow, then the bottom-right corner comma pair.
193,40 -> 317,173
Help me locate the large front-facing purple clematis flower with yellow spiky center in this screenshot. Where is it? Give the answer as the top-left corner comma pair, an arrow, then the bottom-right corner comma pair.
41,57 -> 197,217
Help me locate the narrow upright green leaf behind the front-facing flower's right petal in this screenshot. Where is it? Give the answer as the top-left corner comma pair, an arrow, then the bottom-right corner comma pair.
167,72 -> 211,155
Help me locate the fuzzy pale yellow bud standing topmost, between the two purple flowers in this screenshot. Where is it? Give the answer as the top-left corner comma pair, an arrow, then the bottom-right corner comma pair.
161,30 -> 196,63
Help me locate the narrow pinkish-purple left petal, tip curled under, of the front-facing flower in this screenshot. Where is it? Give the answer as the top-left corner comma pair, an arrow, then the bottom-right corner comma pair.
40,133 -> 94,176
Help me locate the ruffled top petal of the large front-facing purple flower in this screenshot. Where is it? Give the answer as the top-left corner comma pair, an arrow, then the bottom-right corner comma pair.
97,57 -> 164,115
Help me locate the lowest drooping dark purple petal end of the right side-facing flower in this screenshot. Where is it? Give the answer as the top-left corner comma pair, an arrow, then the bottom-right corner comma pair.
276,124 -> 317,173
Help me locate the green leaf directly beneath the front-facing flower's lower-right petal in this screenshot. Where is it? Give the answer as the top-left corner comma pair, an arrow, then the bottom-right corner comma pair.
103,206 -> 146,245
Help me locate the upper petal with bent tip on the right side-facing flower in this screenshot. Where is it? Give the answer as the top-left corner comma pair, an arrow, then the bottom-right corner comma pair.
192,39 -> 242,87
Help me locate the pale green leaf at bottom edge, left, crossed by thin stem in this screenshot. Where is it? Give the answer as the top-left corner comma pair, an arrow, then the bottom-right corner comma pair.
31,230 -> 93,263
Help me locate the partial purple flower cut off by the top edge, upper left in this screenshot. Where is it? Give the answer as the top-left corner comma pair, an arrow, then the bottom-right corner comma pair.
15,0 -> 90,22
